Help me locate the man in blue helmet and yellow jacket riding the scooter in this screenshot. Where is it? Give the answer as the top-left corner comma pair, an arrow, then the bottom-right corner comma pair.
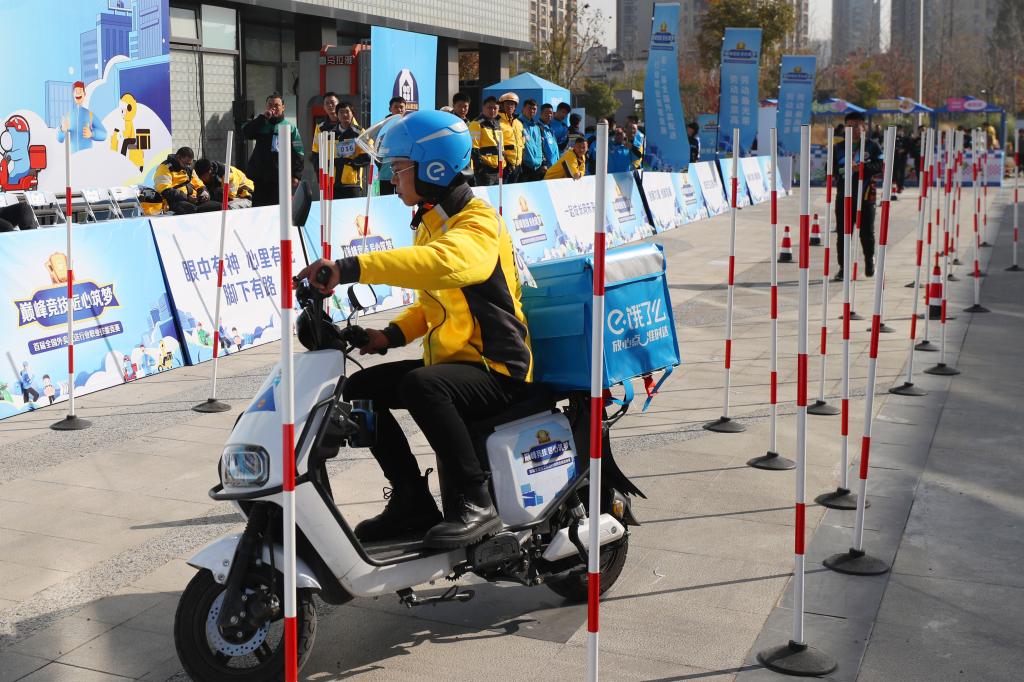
298,111 -> 534,548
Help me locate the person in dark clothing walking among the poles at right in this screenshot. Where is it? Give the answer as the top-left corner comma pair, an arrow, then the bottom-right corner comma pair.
833,112 -> 883,281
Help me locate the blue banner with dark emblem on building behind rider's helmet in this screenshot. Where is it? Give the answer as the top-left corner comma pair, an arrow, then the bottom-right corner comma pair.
362,26 -> 437,126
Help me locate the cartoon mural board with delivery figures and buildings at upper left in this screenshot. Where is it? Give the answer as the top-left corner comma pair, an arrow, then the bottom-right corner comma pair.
0,0 -> 172,191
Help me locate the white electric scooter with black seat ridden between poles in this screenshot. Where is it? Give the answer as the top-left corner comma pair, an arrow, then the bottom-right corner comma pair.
174,270 -> 642,682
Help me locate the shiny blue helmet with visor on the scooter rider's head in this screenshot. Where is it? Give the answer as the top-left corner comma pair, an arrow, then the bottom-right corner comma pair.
377,111 -> 473,187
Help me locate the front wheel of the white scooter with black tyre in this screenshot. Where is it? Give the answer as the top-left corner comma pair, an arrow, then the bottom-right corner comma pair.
174,569 -> 316,682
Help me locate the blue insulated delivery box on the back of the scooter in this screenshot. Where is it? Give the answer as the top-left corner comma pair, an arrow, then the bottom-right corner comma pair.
522,244 -> 679,390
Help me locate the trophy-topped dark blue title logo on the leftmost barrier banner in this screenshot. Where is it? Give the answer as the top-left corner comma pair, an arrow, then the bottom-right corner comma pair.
13,252 -> 121,327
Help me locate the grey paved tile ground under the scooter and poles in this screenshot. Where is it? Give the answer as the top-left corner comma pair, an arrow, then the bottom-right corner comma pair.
0,182 -> 1024,682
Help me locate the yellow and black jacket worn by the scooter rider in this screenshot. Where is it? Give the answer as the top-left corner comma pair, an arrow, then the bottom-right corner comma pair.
341,184 -> 534,381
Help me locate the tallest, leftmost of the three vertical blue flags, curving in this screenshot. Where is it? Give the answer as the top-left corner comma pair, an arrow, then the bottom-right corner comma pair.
643,2 -> 690,171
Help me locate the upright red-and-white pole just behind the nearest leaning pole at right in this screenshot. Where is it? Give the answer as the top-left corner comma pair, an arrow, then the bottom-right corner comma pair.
814,126 -> 857,509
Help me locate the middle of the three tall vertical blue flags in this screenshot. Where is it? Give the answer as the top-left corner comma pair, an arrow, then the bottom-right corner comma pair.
718,29 -> 761,154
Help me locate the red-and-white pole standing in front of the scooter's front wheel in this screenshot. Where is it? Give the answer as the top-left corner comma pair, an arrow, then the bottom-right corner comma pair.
278,123 -> 299,682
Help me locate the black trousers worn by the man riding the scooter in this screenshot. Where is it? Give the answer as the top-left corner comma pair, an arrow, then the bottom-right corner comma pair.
344,360 -> 532,489
